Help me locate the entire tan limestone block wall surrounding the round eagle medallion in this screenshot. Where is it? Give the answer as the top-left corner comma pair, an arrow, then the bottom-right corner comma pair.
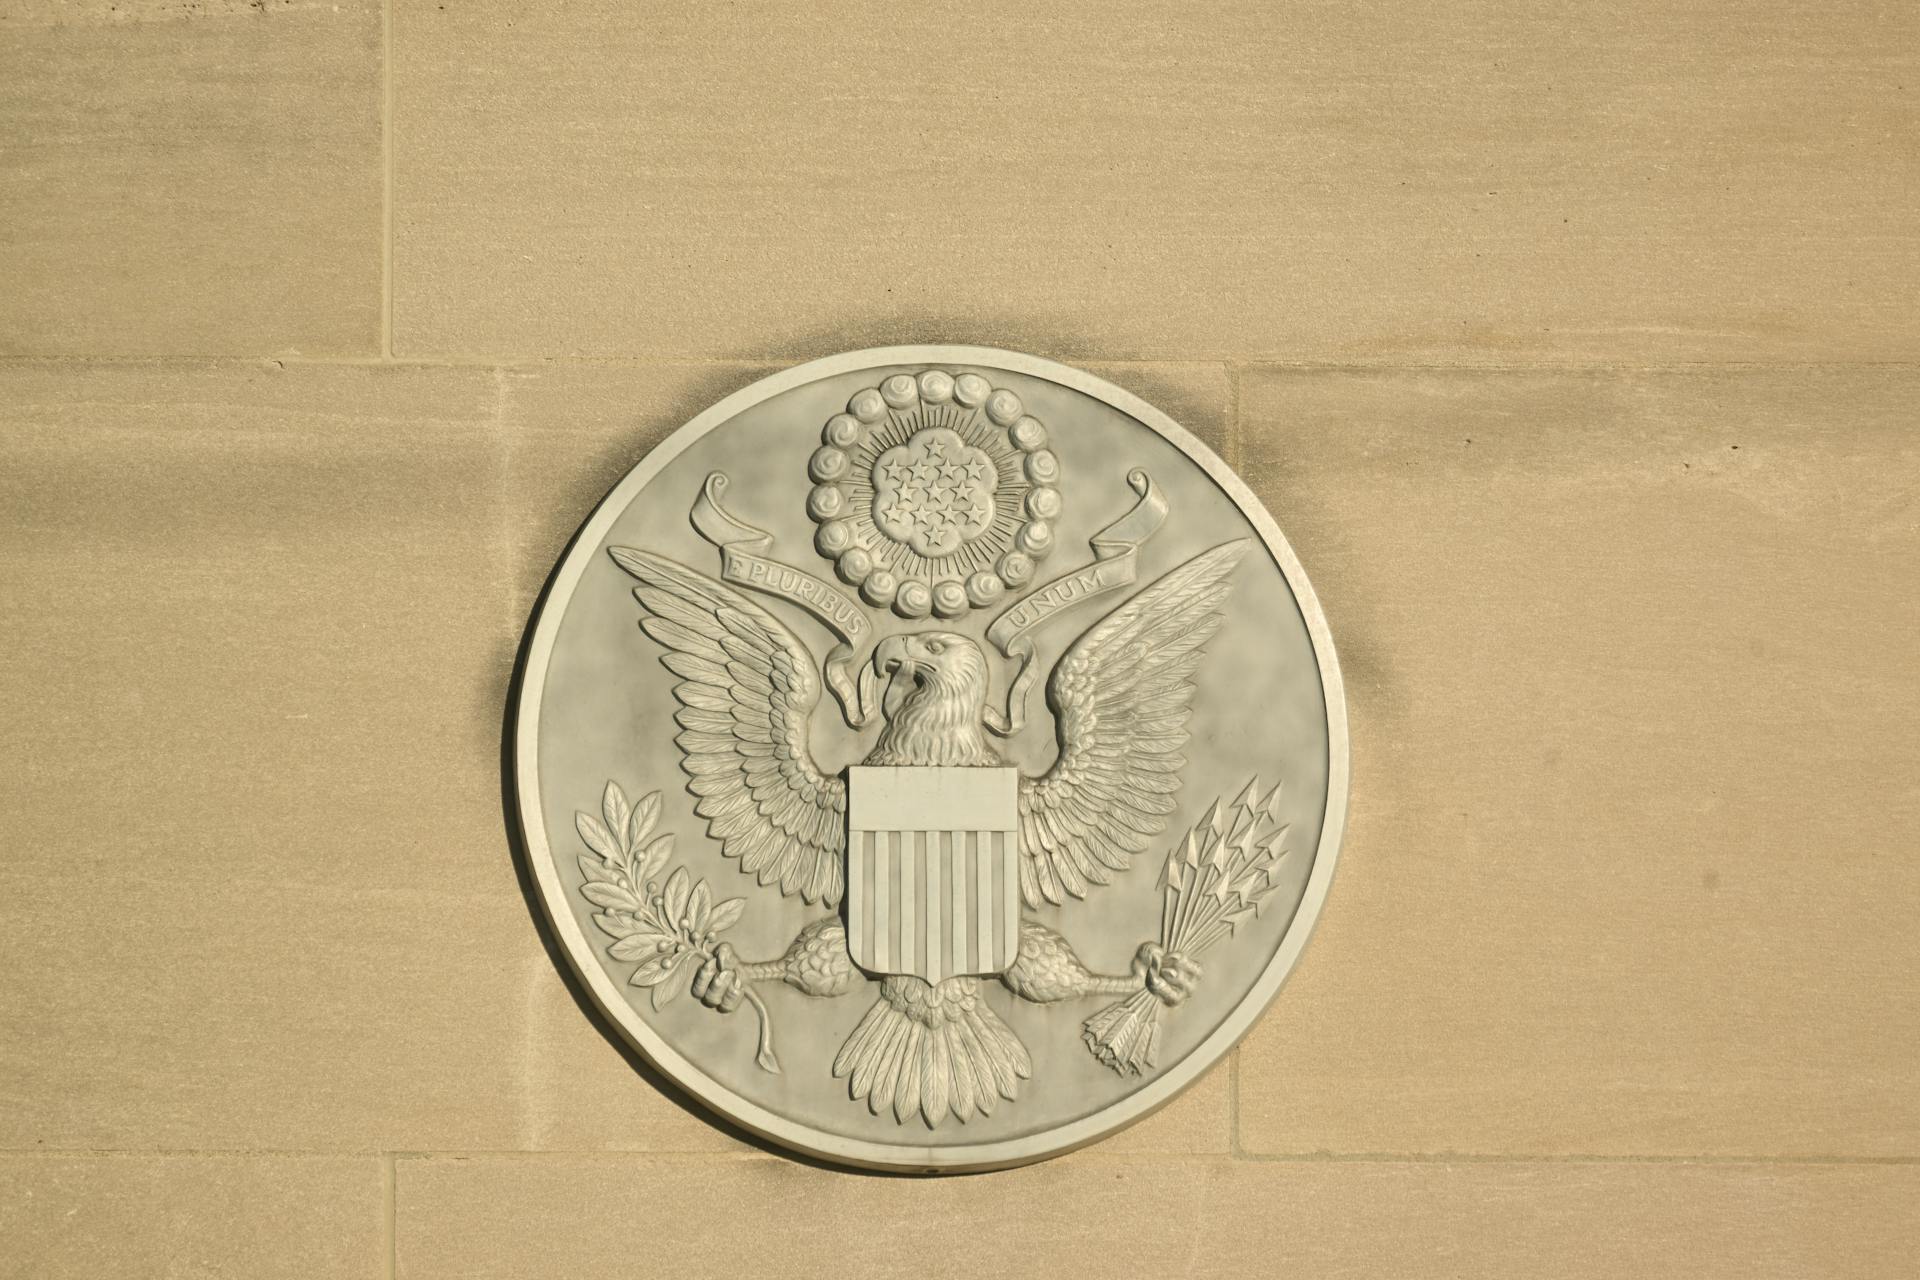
0,0 -> 1920,1280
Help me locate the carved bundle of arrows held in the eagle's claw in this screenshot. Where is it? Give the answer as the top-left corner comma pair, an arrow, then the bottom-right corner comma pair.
1081,777 -> 1286,1075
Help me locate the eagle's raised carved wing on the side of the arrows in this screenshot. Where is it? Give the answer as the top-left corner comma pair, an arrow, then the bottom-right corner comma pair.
1020,539 -> 1252,908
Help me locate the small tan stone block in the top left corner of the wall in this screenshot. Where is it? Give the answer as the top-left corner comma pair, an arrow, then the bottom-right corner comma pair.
0,0 -> 382,355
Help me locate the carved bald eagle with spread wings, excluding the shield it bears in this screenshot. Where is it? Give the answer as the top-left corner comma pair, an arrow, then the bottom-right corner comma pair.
611,539 -> 1250,1126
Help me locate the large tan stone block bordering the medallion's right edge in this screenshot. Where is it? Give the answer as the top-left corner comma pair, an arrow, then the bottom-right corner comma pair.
1240,368 -> 1920,1157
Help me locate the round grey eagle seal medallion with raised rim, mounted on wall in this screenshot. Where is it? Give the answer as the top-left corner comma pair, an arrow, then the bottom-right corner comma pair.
515,347 -> 1348,1173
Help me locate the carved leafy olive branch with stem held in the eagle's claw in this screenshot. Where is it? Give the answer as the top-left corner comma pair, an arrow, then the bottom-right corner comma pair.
574,781 -> 780,1075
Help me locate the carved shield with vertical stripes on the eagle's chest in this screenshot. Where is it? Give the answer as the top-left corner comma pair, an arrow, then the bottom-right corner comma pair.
847,766 -> 1020,983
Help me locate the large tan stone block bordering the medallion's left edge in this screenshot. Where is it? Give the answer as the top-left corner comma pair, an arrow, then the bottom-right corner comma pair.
0,365 -> 543,1150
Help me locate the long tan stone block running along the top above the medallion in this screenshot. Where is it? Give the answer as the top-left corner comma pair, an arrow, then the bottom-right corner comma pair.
394,0 -> 1920,361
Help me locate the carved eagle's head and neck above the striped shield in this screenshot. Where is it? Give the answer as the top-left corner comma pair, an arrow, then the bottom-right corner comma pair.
866,631 -> 1000,764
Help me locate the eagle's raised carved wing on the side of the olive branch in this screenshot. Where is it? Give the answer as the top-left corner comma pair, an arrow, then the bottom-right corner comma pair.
609,547 -> 847,906
